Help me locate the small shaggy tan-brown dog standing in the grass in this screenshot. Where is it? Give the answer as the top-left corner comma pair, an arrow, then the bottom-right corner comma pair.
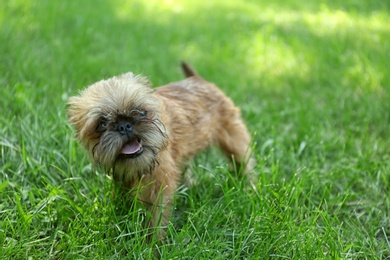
68,63 -> 252,239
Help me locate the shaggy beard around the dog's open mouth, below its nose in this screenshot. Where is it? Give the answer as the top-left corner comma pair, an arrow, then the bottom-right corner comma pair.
91,120 -> 166,183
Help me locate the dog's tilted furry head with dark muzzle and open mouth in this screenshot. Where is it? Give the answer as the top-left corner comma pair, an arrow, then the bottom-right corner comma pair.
68,73 -> 167,182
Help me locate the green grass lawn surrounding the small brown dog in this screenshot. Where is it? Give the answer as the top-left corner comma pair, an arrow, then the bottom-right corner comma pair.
0,0 -> 390,259
